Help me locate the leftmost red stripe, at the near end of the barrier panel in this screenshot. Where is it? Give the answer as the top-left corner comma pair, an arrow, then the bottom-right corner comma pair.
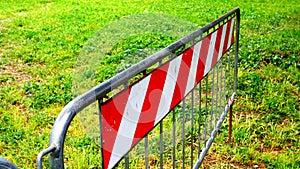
101,89 -> 130,168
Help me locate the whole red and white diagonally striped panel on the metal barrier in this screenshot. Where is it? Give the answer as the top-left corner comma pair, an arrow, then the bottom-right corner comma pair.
101,18 -> 234,168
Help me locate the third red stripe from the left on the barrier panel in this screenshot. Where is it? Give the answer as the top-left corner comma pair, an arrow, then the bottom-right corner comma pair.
169,47 -> 193,110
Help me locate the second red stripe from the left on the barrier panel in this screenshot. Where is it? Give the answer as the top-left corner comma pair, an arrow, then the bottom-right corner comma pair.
131,62 -> 170,146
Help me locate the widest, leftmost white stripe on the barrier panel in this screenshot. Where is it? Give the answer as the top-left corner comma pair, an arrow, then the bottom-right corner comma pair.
108,74 -> 151,168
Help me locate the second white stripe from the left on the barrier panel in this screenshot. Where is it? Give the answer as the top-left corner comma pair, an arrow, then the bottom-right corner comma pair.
154,54 -> 182,125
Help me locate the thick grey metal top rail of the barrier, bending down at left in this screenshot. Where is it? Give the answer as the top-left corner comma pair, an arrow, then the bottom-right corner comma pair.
37,8 -> 240,169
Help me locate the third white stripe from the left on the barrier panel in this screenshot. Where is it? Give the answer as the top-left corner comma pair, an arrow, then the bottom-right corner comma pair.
184,41 -> 202,96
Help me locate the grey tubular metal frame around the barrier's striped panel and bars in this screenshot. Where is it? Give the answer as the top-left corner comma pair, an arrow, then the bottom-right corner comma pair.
37,8 -> 240,169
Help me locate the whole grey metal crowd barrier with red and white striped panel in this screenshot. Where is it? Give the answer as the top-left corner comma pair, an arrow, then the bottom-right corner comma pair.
0,8 -> 240,169
